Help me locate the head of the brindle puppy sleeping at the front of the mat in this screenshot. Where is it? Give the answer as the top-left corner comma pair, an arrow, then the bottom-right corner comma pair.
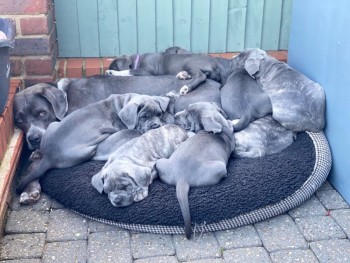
91,161 -> 151,207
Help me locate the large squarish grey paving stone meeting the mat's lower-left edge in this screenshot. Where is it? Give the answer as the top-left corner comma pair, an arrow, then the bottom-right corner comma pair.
47,209 -> 88,242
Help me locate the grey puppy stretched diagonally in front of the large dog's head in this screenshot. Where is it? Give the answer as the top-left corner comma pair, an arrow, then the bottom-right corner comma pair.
17,93 -> 169,203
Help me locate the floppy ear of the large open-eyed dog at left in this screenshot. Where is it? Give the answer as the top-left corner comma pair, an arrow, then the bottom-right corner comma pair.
40,85 -> 68,120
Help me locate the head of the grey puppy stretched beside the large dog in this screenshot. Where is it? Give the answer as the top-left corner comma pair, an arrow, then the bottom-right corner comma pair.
118,95 -> 170,133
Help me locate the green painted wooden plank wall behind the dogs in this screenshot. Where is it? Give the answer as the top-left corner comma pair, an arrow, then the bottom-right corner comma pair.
55,0 -> 293,57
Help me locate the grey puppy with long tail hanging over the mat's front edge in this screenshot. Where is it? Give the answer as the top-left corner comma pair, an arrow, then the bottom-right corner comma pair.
156,102 -> 235,238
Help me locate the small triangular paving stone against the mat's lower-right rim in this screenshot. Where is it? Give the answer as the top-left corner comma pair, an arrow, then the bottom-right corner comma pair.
288,195 -> 327,218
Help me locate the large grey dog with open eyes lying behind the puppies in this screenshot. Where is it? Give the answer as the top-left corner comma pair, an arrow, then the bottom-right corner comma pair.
13,75 -> 220,150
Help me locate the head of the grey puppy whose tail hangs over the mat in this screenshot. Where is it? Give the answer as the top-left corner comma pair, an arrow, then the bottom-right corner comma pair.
175,102 -> 233,133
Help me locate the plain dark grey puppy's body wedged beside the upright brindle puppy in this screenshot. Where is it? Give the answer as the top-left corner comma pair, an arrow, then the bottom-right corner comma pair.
221,69 -> 272,132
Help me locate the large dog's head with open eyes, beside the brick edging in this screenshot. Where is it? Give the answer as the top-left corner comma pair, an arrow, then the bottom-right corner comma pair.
13,83 -> 68,150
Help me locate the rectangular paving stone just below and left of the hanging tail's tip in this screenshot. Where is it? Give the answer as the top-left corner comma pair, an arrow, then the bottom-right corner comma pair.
131,233 -> 175,259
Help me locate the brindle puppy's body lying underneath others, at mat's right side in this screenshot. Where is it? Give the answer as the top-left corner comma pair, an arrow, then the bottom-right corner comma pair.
232,115 -> 296,158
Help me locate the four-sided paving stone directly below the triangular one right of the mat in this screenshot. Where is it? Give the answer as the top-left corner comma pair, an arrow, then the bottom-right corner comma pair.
295,216 -> 346,242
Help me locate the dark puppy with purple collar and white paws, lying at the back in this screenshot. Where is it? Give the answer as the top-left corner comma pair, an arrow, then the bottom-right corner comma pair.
106,53 -> 227,95
